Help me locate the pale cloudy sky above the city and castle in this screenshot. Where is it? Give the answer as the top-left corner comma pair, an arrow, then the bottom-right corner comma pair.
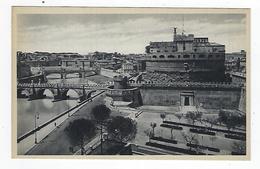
16,14 -> 246,54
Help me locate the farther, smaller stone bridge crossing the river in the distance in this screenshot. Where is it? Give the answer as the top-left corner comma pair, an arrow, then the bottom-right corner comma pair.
41,66 -> 99,79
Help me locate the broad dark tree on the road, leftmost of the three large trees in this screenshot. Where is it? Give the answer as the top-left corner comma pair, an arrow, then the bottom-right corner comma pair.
65,119 -> 96,155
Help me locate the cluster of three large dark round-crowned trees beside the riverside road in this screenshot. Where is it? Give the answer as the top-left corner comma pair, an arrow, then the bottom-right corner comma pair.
65,105 -> 136,155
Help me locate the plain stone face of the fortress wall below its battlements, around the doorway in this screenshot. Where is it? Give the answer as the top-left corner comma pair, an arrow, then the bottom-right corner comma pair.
140,88 -> 240,109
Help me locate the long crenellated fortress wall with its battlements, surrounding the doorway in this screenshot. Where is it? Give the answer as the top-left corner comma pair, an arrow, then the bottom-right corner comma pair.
128,81 -> 242,109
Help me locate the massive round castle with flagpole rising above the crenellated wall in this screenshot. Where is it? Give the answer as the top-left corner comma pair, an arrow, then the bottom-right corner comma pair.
142,28 -> 225,81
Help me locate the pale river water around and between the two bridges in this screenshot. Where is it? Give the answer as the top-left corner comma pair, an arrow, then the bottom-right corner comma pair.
17,74 -> 98,138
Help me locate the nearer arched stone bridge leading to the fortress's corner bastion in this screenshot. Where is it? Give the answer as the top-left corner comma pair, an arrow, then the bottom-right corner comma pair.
17,83 -> 111,102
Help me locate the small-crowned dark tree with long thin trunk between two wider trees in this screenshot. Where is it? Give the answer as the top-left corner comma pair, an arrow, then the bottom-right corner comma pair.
91,104 -> 111,154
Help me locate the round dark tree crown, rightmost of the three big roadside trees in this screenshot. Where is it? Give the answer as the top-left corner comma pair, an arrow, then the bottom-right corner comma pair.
107,116 -> 137,142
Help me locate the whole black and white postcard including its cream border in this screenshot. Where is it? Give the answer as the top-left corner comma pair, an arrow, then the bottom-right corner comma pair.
12,7 -> 250,159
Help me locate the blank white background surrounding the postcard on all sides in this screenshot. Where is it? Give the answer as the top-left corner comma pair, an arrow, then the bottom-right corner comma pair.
0,0 -> 260,169
